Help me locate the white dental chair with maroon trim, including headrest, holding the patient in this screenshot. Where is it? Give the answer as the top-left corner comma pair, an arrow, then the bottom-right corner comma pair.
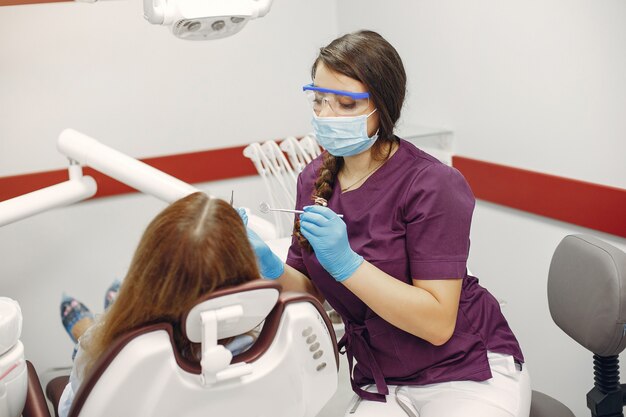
40,280 -> 339,417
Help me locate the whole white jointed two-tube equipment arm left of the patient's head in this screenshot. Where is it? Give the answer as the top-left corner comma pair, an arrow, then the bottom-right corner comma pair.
0,129 -> 199,226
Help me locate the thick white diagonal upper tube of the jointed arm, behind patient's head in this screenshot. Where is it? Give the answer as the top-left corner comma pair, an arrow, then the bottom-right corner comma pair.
57,129 -> 199,203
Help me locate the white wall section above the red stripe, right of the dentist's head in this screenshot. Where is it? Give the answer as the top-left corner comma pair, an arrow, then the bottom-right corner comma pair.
337,0 -> 626,188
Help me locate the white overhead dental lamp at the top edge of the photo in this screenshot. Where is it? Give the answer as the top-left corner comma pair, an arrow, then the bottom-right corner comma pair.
143,0 -> 272,40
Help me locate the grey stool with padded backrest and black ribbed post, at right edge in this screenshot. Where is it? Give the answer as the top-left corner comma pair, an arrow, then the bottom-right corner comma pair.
530,235 -> 626,417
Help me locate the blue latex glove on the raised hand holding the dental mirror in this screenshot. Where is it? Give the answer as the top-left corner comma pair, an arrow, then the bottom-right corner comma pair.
300,206 -> 363,282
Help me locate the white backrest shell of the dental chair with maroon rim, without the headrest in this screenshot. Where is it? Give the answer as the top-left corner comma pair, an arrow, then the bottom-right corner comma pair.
69,288 -> 339,417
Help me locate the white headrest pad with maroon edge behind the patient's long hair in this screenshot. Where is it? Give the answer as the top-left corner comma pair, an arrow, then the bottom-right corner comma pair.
182,279 -> 281,343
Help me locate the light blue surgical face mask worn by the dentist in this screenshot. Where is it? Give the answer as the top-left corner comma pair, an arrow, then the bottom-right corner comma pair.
311,109 -> 378,156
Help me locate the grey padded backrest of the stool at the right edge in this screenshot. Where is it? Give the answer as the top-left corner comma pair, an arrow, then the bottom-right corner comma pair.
548,235 -> 626,356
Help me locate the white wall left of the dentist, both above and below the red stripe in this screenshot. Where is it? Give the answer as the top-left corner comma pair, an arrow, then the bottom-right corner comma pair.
0,0 -> 337,378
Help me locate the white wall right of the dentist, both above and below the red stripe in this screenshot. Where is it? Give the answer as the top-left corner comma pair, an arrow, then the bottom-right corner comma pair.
337,0 -> 626,417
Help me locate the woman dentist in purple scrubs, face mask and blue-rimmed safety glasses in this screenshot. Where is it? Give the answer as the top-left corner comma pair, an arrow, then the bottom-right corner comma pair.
248,31 -> 531,417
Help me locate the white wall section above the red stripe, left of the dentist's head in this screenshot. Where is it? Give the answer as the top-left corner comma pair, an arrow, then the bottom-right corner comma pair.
0,0 -> 336,175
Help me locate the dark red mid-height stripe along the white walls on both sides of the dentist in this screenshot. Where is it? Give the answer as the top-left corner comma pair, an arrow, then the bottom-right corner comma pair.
0,146 -> 626,237
